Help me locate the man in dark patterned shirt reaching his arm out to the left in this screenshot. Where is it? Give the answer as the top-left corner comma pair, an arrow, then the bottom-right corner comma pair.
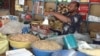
45,1 -> 82,34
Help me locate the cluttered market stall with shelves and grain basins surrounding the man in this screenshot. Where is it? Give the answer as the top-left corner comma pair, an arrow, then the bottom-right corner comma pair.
0,0 -> 100,56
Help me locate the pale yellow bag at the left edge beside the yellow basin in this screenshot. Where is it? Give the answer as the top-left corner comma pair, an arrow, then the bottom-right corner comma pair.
0,33 -> 9,54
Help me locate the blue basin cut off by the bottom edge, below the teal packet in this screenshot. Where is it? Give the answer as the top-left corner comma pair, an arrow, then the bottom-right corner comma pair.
51,50 -> 88,56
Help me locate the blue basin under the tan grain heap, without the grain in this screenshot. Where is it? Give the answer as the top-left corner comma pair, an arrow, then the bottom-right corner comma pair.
32,47 -> 61,56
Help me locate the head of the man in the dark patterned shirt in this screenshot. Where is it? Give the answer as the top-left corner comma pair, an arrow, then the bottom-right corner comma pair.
68,1 -> 80,13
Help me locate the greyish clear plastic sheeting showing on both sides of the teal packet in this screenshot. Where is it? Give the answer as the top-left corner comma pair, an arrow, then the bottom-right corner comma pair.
46,32 -> 92,45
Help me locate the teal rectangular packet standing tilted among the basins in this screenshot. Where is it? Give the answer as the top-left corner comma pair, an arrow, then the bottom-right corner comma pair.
63,34 -> 78,49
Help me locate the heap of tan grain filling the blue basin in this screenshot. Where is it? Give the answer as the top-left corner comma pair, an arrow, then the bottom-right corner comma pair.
32,40 -> 62,51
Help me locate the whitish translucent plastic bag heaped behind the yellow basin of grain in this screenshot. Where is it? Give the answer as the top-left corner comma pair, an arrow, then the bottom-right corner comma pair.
0,21 -> 23,34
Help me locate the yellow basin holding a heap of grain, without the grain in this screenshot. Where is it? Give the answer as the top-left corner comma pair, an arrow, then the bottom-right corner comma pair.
10,40 -> 31,48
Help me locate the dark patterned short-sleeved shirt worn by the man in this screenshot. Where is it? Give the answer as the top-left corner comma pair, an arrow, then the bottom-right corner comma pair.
63,12 -> 82,34
